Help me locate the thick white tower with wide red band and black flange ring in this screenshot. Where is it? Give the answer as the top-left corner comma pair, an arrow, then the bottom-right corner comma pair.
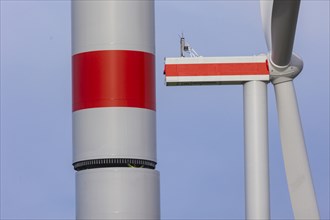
72,0 -> 160,219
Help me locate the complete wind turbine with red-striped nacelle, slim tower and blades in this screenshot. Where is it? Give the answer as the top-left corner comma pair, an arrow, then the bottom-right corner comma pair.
165,0 -> 319,219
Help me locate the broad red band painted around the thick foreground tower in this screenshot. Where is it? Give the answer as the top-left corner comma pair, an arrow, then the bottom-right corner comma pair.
72,50 -> 156,111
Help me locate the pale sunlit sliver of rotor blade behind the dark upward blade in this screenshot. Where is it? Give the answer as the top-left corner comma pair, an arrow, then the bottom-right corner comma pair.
260,0 -> 274,51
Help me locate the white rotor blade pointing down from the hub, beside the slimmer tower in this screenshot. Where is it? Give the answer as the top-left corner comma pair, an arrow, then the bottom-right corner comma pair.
274,81 -> 320,219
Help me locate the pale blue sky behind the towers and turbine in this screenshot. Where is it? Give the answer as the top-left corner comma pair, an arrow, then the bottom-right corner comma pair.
0,0 -> 330,219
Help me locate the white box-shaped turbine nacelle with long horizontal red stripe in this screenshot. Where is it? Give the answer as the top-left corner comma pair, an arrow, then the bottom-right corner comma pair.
164,55 -> 269,86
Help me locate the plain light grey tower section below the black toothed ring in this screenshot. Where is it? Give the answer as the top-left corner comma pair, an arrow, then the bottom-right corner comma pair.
76,168 -> 160,220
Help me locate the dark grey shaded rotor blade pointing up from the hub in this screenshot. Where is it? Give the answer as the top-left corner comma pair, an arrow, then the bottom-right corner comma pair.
271,0 -> 300,67
